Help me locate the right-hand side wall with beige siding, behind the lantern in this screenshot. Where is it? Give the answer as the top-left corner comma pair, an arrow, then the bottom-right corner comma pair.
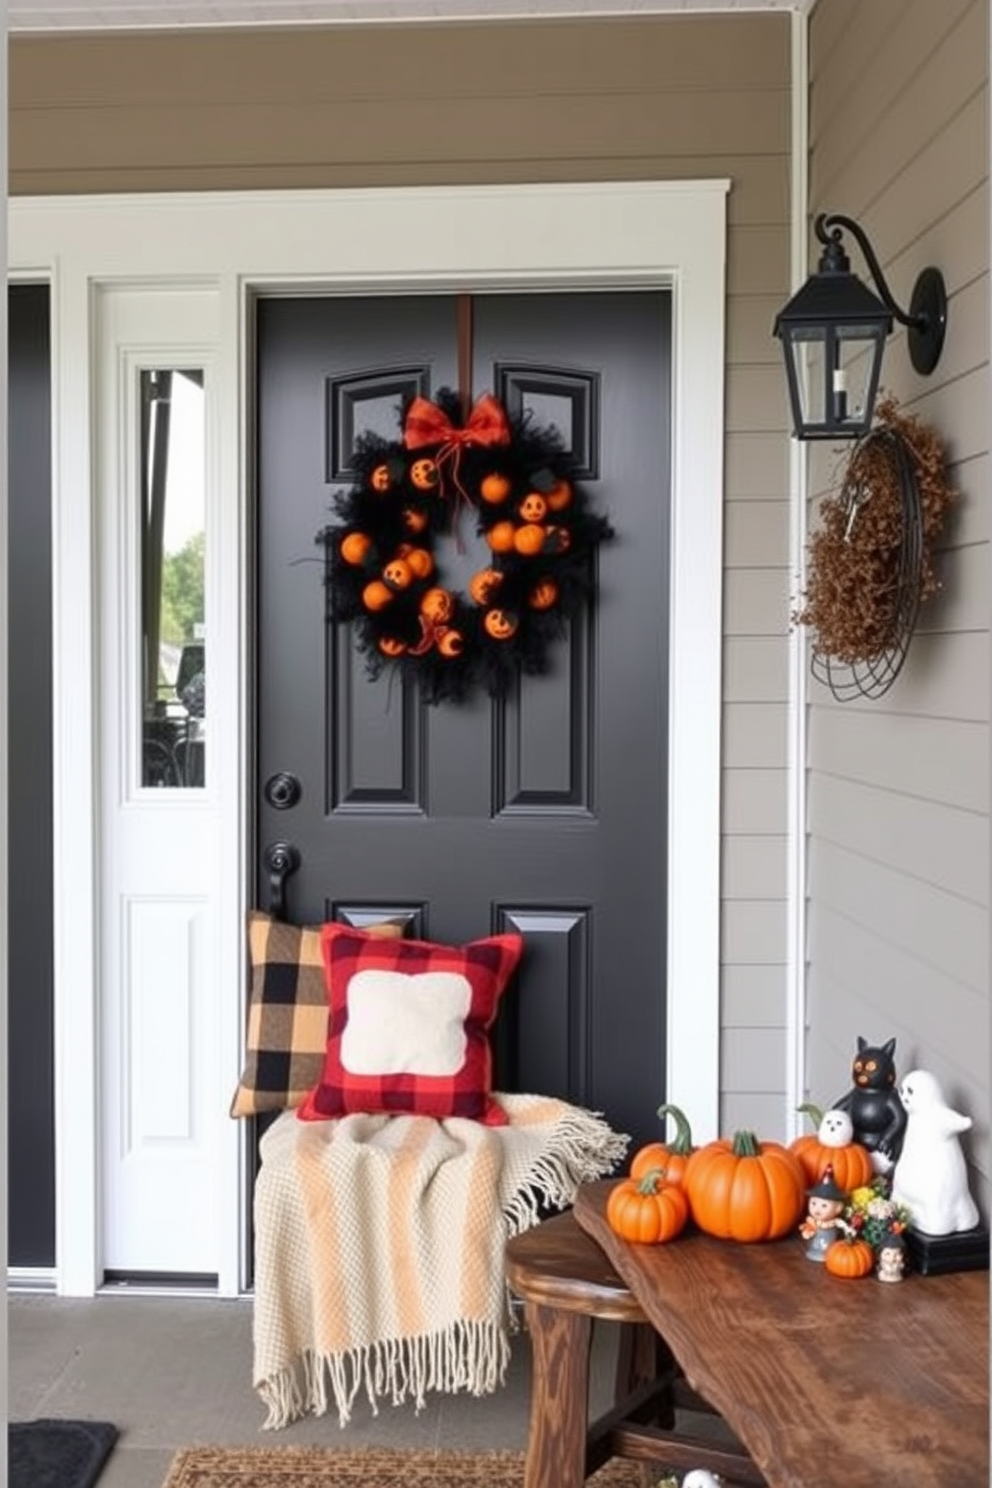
809,0 -> 991,1217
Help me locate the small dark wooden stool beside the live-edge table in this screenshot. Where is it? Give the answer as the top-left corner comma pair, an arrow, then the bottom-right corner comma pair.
506,1210 -> 764,1488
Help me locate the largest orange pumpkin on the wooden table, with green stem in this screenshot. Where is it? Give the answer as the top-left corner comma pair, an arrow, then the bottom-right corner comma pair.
683,1131 -> 806,1241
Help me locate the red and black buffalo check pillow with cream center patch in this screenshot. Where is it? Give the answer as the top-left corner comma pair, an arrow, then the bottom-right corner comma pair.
297,924 -> 524,1126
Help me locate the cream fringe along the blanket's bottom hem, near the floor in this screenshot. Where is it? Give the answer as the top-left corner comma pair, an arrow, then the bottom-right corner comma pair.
256,1318 -> 510,1431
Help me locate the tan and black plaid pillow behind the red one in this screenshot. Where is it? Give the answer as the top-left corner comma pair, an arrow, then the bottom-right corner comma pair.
231,909 -> 403,1116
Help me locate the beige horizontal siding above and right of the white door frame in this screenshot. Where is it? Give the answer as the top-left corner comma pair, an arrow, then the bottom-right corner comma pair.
10,15 -> 791,1135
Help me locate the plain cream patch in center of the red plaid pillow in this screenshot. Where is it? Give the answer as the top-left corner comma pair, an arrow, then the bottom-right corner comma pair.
341,970 -> 471,1079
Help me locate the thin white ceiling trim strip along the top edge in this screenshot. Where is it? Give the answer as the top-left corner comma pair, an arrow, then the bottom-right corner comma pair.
7,0 -> 814,33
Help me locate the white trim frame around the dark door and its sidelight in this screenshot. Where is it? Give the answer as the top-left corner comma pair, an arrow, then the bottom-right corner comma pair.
9,180 -> 729,1296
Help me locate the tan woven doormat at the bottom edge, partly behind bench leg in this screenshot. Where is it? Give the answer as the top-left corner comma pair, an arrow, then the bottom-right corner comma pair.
162,1446 -> 650,1488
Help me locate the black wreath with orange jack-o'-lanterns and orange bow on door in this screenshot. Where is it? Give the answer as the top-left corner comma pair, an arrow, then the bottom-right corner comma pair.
317,388 -> 611,702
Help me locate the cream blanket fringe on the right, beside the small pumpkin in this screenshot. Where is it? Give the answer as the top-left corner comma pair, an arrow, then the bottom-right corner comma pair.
503,1106 -> 631,1235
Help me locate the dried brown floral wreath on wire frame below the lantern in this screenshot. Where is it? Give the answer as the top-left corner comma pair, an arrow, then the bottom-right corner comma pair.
793,397 -> 955,701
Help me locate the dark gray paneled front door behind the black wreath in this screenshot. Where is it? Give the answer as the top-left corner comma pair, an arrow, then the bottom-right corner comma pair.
253,292 -> 671,1141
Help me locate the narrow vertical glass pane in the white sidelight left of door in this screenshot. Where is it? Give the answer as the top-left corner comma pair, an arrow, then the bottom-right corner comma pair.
140,368 -> 207,787
